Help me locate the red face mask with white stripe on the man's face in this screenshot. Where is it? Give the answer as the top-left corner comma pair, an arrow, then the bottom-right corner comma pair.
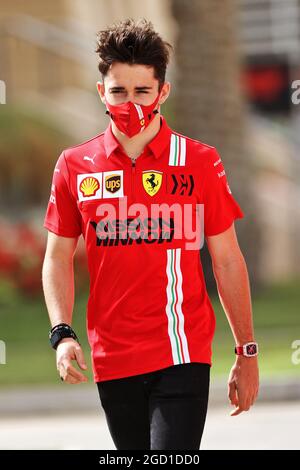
105,93 -> 160,137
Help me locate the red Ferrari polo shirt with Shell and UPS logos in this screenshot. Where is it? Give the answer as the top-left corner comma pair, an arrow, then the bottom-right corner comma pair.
44,116 -> 244,382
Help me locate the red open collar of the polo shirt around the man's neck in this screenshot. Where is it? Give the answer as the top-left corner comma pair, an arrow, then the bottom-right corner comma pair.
104,115 -> 172,159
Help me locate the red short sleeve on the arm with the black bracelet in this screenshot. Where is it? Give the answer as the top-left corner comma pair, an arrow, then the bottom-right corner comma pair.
43,152 -> 82,237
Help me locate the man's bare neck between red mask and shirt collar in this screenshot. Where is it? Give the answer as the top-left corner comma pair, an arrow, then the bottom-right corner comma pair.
111,113 -> 160,159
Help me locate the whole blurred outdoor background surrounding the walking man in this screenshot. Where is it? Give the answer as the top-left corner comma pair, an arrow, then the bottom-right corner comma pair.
0,0 -> 300,449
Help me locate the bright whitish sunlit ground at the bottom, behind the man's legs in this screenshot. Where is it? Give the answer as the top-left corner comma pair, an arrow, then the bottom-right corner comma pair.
0,401 -> 300,450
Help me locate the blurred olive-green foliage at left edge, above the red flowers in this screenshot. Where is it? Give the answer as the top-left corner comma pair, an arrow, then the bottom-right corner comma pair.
0,105 -> 72,209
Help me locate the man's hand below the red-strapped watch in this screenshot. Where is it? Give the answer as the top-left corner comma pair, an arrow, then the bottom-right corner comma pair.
228,356 -> 259,416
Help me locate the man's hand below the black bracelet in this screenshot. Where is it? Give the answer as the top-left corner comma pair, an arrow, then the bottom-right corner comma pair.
56,338 -> 88,384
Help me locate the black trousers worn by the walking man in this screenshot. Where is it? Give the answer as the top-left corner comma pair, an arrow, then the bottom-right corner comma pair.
97,362 -> 210,450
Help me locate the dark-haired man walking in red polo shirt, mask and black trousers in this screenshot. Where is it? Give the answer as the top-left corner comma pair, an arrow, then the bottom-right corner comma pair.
43,19 -> 258,450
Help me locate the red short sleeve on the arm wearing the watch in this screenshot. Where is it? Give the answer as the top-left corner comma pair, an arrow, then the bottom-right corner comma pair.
203,148 -> 244,236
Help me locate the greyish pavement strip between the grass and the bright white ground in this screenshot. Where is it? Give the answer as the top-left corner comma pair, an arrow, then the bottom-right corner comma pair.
0,377 -> 300,418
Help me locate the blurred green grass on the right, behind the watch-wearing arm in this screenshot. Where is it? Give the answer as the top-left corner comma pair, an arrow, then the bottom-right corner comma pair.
212,280 -> 300,377
